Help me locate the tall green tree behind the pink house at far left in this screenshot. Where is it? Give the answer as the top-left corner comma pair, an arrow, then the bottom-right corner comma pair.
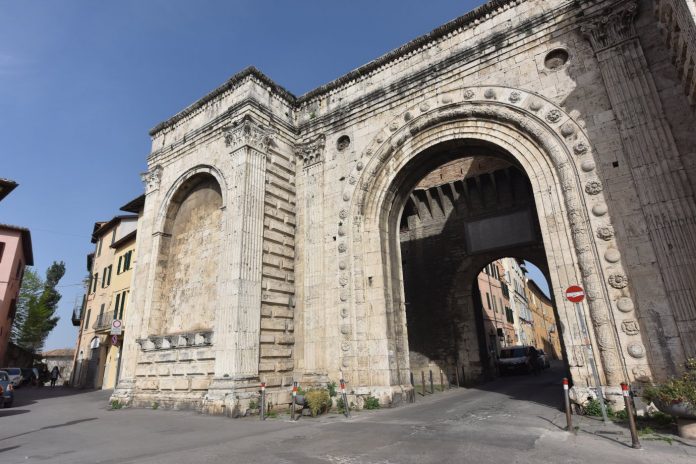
12,261 -> 65,352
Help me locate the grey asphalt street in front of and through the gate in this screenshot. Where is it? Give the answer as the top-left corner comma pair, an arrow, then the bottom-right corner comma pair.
0,371 -> 696,464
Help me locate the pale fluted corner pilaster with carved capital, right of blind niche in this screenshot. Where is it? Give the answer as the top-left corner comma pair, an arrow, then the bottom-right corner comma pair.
204,116 -> 272,415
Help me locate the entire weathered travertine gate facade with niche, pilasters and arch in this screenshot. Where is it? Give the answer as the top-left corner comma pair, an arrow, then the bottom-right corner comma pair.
114,0 -> 696,415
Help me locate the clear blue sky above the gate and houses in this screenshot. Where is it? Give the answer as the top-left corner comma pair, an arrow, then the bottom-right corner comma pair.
0,0 -> 538,349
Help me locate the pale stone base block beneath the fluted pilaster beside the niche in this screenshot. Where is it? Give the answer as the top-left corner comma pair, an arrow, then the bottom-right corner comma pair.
202,376 -> 259,417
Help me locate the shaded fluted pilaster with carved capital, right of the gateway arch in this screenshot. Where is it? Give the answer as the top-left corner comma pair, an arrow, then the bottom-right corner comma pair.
581,1 -> 696,358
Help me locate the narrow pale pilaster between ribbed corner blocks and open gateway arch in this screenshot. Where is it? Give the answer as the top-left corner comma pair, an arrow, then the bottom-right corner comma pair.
295,135 -> 332,384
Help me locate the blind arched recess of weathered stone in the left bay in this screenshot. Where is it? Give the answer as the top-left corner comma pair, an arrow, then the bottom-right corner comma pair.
149,172 -> 223,334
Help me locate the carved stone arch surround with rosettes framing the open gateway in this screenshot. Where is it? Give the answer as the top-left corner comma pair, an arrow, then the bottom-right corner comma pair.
337,86 -> 649,396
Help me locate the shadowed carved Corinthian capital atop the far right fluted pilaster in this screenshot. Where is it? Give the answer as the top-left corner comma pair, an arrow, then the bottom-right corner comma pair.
580,0 -> 638,53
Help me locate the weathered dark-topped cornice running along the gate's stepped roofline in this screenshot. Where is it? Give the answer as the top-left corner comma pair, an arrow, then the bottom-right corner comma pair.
150,0 -> 527,137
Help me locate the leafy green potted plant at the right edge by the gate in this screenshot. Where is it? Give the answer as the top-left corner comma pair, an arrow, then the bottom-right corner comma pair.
643,358 -> 696,438
